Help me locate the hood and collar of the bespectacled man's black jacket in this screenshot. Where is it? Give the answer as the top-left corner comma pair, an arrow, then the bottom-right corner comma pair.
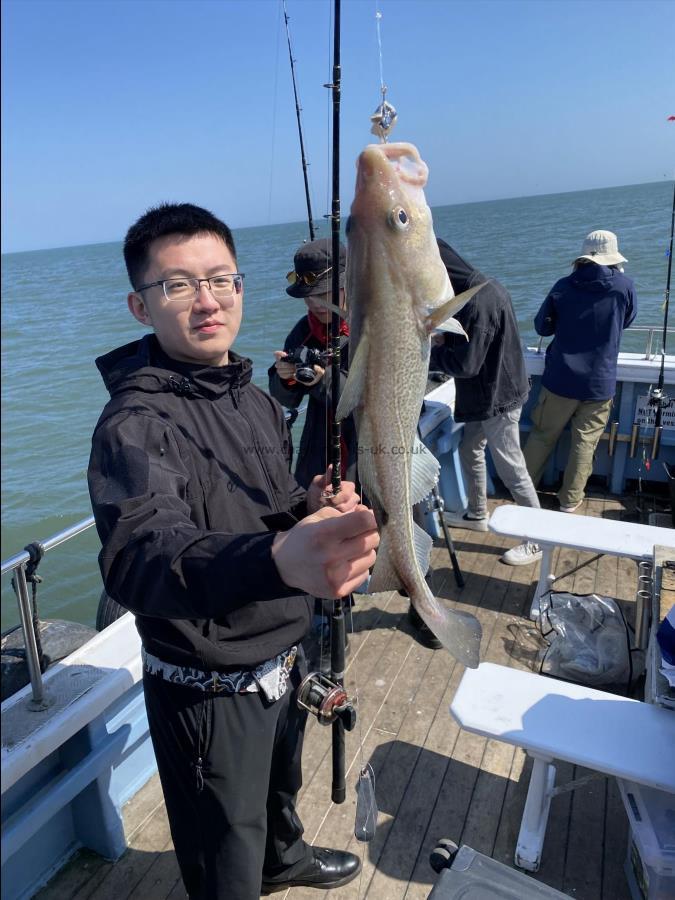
96,334 -> 253,399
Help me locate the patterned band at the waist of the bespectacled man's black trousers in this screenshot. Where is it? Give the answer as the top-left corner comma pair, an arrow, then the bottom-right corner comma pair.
141,647 -> 298,700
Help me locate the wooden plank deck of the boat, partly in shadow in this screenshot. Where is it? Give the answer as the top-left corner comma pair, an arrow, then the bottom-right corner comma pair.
38,495 -> 648,900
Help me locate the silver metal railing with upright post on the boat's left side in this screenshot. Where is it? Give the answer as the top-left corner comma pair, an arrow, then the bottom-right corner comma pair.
2,516 -> 94,710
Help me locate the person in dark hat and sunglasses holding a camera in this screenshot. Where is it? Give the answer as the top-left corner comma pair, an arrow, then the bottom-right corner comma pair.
268,238 -> 358,672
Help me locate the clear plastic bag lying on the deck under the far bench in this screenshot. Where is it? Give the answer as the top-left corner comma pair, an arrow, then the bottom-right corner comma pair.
539,591 -> 640,689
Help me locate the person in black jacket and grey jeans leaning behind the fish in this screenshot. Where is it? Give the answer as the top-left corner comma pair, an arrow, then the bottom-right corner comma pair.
430,238 -> 542,566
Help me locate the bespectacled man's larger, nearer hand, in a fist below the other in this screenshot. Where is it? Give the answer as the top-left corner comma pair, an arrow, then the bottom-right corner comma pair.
272,504 -> 380,599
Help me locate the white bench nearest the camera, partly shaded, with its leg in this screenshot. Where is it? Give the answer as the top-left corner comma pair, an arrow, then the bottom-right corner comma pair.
450,663 -> 675,871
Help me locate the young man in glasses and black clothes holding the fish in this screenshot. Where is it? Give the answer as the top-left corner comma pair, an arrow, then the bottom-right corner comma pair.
89,204 -> 379,900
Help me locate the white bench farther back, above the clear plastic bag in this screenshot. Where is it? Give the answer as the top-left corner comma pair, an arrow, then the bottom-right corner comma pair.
489,506 -> 675,619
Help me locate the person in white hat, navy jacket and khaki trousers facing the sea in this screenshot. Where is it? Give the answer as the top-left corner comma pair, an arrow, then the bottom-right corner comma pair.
524,231 -> 637,513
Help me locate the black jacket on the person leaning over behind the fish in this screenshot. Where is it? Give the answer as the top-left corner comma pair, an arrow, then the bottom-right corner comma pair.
430,240 -> 529,422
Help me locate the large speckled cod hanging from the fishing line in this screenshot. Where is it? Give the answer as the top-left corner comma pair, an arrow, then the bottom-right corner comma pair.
336,142 -> 483,668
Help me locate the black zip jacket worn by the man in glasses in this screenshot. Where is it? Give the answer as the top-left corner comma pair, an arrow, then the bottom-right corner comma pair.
88,335 -> 311,671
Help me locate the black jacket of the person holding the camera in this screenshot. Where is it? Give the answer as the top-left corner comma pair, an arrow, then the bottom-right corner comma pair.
268,316 -> 358,487
